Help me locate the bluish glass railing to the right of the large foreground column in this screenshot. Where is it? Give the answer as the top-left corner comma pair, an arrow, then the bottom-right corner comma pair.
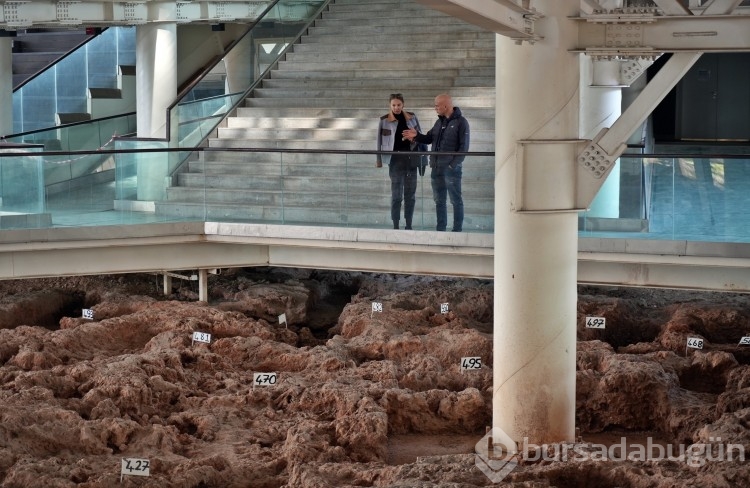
579,155 -> 750,242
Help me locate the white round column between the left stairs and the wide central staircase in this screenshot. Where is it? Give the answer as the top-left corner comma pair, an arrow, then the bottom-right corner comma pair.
136,22 -> 177,202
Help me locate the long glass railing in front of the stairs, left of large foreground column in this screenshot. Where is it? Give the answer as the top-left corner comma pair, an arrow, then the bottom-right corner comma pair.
0,145 -> 494,232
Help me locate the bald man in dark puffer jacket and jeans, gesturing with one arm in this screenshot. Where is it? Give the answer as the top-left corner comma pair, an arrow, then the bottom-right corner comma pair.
402,93 -> 469,232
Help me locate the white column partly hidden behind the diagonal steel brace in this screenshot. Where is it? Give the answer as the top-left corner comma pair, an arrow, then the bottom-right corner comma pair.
580,56 -> 622,219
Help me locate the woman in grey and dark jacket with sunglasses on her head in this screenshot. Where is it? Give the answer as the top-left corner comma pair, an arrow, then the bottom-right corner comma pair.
377,93 -> 420,230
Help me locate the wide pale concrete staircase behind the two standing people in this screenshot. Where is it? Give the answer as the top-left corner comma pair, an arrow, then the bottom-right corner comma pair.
155,0 -> 495,231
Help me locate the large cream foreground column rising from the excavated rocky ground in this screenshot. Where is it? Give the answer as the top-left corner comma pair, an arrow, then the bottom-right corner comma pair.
492,0 -> 580,449
